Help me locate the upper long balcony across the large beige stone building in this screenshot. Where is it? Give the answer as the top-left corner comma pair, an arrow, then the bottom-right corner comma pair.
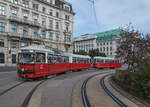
9,16 -> 41,27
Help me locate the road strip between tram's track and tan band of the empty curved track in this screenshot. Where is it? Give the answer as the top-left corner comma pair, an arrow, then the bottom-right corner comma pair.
29,70 -> 108,107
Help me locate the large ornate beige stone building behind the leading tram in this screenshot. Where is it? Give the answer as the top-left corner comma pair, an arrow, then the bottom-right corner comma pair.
0,0 -> 75,66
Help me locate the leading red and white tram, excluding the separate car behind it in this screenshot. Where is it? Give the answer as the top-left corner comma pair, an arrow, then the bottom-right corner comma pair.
18,45 -> 90,78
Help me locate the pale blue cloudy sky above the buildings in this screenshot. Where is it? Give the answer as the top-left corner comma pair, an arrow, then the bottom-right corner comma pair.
66,0 -> 150,37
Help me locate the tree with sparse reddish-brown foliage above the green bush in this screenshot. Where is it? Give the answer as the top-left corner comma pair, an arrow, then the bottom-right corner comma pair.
116,29 -> 150,71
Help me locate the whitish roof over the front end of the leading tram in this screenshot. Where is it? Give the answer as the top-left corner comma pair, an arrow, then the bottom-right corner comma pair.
20,45 -> 54,53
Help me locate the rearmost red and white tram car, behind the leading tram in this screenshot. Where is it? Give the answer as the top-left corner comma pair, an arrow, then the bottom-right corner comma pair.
93,57 -> 121,68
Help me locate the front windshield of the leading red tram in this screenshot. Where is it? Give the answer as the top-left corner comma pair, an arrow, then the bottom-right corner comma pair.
18,53 -> 35,63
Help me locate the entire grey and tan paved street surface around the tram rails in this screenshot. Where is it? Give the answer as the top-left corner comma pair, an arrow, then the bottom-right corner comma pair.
0,69 -> 137,107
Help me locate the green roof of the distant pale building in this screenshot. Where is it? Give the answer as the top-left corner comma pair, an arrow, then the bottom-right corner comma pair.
95,29 -> 125,42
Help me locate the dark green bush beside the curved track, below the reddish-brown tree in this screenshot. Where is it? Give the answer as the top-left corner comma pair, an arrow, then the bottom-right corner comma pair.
113,58 -> 150,99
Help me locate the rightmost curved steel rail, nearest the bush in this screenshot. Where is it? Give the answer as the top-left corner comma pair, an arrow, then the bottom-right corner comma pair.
100,75 -> 127,107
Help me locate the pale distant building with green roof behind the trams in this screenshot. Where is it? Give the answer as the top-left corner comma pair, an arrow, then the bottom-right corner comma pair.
73,29 -> 124,57
